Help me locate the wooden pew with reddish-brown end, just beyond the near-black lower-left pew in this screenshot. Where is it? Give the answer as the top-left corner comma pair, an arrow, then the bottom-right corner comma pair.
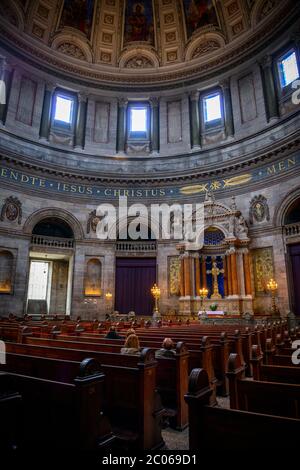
1,340 -> 164,450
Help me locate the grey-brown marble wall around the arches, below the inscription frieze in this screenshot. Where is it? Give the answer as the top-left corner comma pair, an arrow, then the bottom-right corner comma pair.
0,175 -> 300,318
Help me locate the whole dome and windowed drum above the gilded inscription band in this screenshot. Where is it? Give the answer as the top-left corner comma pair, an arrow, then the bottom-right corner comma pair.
0,0 -> 300,180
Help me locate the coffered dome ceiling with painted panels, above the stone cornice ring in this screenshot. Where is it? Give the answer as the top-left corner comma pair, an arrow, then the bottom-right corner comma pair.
0,0 -> 285,85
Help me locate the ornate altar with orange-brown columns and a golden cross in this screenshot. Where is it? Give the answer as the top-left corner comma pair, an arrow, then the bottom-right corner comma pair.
177,192 -> 253,318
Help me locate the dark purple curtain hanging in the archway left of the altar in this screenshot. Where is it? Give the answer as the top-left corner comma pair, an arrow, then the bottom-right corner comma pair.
115,258 -> 156,315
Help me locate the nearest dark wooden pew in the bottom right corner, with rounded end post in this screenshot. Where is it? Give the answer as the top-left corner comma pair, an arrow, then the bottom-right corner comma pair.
185,369 -> 300,454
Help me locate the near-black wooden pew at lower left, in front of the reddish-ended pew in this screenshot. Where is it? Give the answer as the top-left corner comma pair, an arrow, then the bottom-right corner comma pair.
1,360 -> 115,452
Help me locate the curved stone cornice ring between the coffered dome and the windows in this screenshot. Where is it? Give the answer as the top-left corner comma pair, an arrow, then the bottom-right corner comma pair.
0,2 -> 300,91
